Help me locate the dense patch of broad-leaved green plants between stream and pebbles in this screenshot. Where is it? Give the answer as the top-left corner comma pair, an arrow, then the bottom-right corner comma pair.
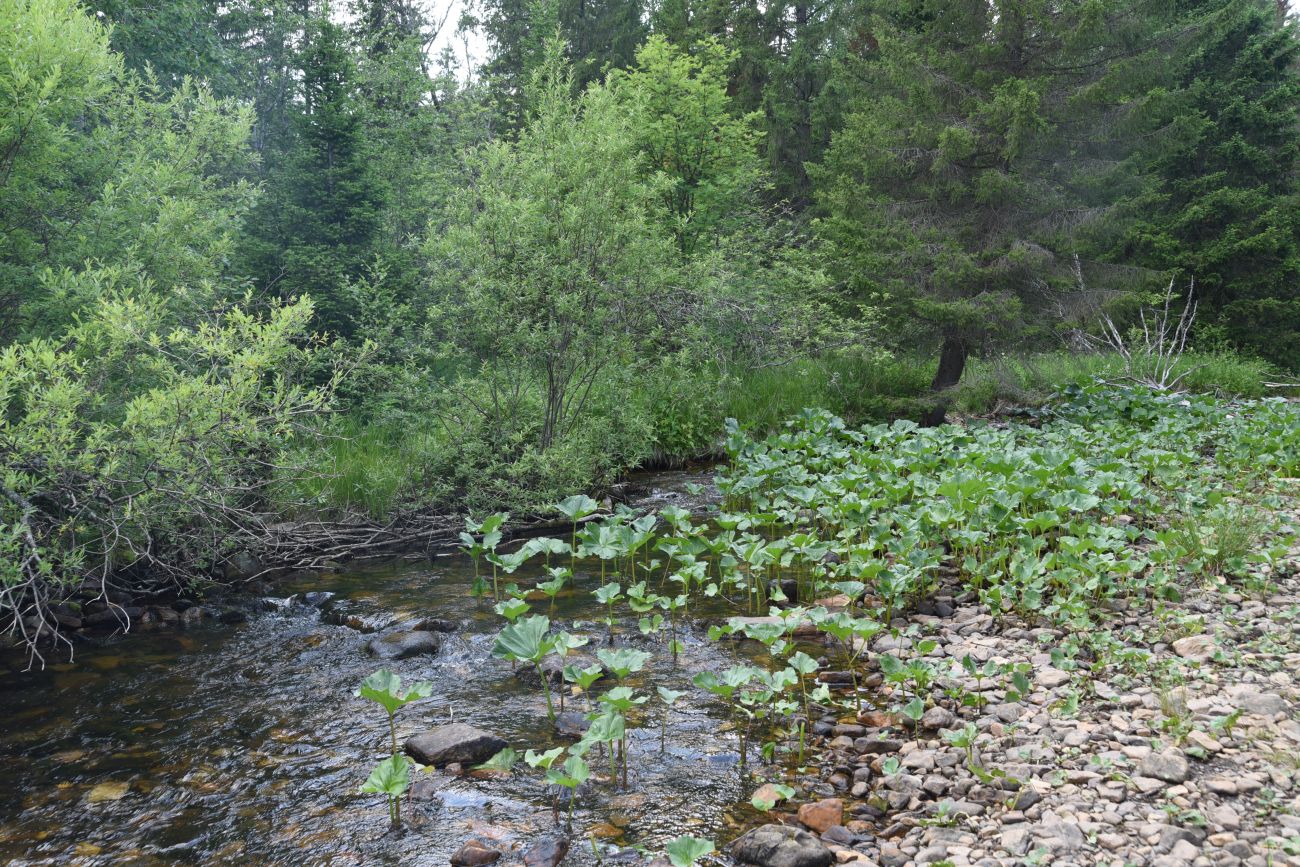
454,387 -> 1300,809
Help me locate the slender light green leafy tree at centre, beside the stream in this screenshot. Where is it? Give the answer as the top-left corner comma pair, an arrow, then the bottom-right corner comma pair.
428,47 -> 671,454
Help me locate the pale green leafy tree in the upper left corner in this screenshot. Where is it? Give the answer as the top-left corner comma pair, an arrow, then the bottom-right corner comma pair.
0,0 -> 252,339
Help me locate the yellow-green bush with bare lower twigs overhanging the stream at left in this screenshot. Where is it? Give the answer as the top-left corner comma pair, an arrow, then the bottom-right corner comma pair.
0,296 -> 332,660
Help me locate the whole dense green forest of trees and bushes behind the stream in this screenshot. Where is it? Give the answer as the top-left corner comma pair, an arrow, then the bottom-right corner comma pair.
0,0 -> 1300,636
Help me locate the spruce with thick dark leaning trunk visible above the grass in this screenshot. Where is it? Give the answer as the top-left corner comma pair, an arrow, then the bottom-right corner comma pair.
815,0 -> 1162,421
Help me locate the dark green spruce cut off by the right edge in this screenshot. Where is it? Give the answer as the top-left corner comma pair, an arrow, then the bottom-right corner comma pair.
1112,0 -> 1300,365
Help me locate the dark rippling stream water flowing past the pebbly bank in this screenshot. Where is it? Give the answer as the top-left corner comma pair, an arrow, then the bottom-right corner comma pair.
0,477 -> 780,864
